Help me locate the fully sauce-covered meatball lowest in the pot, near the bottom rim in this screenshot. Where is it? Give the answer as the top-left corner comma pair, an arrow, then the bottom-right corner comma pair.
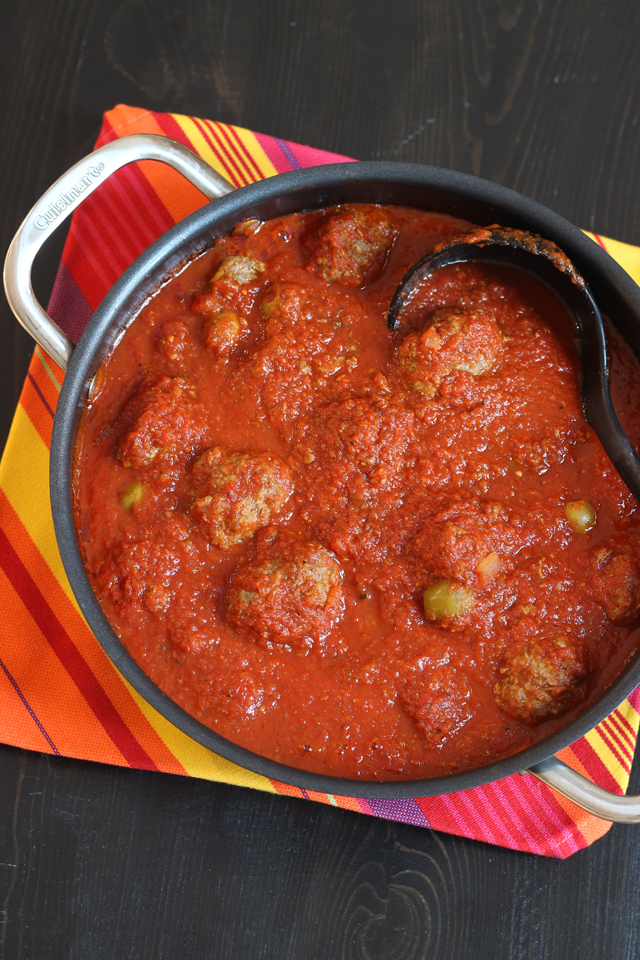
400,665 -> 472,747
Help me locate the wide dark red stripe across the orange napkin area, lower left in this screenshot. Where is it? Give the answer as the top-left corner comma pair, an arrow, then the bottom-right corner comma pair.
0,529 -> 160,770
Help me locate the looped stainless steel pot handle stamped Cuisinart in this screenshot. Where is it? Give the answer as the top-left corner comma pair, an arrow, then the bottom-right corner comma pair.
4,133 -> 234,370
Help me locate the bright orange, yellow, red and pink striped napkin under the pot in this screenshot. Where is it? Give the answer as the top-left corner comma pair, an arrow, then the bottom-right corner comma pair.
0,106 -> 640,858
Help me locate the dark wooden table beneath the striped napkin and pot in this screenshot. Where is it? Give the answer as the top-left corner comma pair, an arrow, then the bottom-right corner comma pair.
0,0 -> 640,960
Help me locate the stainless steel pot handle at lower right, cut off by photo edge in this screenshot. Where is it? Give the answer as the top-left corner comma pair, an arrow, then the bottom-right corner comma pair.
523,757 -> 640,823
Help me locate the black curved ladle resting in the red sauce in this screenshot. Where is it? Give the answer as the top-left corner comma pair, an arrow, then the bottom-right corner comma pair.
387,224 -> 640,501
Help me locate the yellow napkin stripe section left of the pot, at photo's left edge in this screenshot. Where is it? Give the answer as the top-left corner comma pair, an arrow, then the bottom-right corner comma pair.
0,403 -> 84,619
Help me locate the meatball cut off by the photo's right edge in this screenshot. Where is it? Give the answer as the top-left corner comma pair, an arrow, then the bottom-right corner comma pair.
590,543 -> 640,623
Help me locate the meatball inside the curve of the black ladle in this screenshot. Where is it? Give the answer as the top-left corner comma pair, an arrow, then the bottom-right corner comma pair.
397,309 -> 504,396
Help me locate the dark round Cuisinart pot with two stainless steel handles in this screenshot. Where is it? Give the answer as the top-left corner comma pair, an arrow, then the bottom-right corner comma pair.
4,135 -> 640,822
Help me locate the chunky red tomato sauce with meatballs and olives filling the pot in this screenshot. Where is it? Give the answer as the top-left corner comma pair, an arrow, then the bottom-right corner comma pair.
74,206 -> 640,780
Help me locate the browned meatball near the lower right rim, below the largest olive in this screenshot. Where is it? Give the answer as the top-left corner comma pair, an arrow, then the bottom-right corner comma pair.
494,636 -> 586,724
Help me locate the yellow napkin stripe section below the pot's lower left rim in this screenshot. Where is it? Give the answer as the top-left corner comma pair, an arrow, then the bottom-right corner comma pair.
123,678 -> 276,793
